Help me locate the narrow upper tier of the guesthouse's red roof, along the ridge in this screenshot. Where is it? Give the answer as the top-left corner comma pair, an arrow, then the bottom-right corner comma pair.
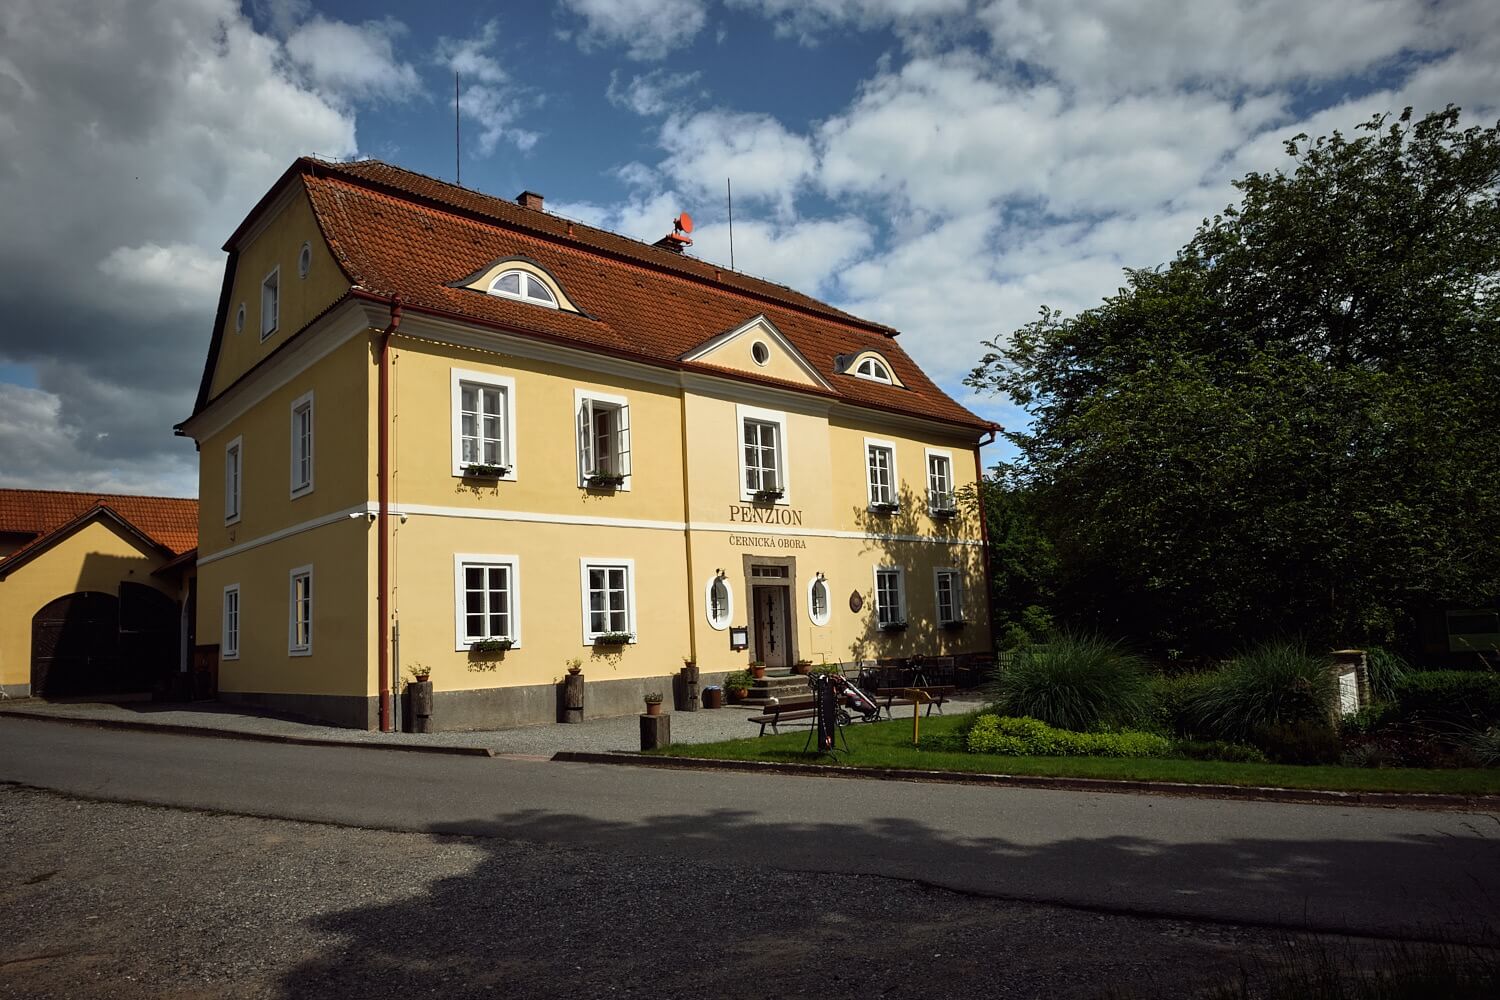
302,156 -> 900,339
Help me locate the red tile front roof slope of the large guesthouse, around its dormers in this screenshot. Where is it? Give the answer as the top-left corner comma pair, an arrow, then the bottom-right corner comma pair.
289,159 -> 993,432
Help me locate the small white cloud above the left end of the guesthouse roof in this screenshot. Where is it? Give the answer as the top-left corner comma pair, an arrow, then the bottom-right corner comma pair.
287,13 -> 422,100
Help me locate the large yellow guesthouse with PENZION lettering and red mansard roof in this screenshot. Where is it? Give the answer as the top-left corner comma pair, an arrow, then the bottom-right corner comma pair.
180,159 -> 993,729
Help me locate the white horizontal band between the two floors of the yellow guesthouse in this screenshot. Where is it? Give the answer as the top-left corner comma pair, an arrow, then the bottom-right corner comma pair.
198,502 -> 984,565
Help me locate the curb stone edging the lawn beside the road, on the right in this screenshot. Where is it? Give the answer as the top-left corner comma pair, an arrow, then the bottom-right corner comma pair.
552,750 -> 1500,813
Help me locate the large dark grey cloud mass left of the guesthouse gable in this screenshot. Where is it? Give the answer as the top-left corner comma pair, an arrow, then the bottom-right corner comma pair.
0,0 -> 357,492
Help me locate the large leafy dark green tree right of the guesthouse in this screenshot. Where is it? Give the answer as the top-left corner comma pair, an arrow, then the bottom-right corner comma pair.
968,106 -> 1500,655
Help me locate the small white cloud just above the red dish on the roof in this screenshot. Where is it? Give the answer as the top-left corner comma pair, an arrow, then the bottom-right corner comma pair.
659,109 -> 818,214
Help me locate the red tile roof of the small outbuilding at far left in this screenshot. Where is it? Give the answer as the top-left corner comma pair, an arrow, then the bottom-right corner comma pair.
0,489 -> 198,559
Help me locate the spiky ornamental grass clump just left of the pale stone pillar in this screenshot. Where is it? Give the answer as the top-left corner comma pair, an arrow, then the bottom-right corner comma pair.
1191,643 -> 1338,742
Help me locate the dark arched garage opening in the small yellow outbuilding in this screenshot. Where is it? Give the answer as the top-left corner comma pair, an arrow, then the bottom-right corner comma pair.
32,583 -> 179,697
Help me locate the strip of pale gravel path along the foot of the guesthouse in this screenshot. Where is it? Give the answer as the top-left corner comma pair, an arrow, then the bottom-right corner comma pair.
0,700 -> 978,756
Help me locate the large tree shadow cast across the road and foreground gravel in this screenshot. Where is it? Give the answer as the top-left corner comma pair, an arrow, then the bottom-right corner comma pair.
282,803 -> 1500,999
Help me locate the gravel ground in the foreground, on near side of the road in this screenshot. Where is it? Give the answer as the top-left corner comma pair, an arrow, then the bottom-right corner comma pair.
0,786 -> 1332,1000
